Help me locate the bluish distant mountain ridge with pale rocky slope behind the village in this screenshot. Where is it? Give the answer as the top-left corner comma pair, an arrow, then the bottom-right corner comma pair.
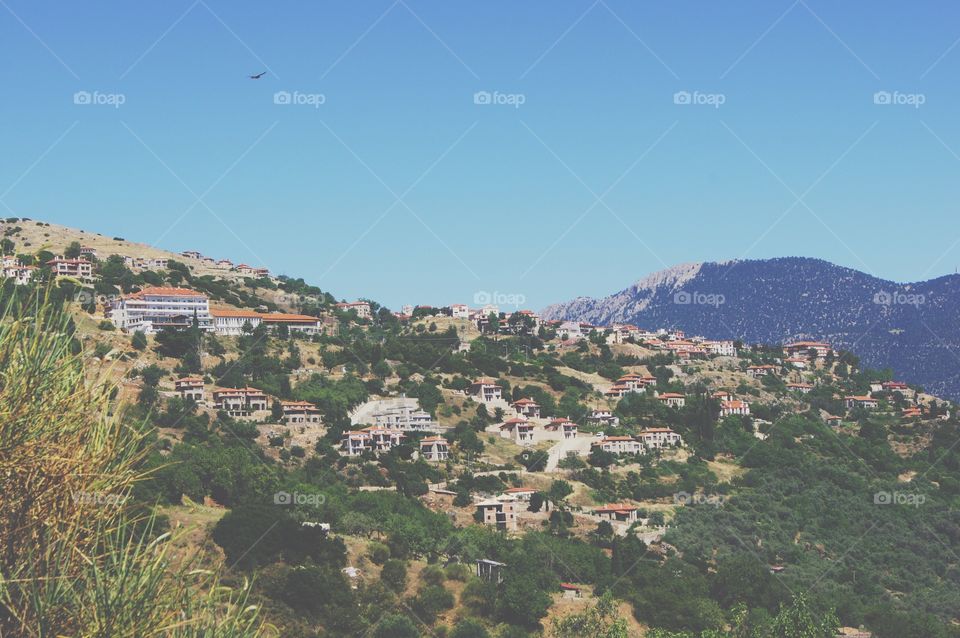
542,257 -> 960,400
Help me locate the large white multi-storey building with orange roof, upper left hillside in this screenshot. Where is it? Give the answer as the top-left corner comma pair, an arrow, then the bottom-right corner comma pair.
110,286 -> 213,333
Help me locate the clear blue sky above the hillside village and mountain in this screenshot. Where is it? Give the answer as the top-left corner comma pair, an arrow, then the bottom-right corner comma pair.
0,0 -> 960,308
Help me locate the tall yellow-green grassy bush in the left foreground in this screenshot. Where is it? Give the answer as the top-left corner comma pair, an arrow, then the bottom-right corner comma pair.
0,300 -> 264,638
